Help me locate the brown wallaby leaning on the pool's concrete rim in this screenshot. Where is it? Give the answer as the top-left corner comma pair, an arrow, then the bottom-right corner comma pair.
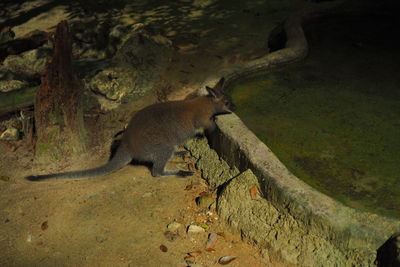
26,78 -> 235,181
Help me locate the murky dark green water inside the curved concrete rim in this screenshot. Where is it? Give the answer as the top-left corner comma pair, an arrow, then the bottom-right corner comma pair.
230,17 -> 400,218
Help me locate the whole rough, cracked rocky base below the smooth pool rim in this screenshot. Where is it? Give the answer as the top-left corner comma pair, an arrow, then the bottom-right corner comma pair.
185,138 -> 376,267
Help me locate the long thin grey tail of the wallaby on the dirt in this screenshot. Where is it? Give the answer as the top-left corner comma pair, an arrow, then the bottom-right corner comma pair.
25,145 -> 132,182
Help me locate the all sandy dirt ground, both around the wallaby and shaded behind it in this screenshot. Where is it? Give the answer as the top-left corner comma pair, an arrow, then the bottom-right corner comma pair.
0,0 -> 310,267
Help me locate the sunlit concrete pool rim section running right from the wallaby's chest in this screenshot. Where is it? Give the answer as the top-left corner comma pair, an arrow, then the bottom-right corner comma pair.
211,114 -> 400,250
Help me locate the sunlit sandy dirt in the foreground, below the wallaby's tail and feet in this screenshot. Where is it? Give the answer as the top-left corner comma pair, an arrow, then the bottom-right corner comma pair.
0,141 -> 284,266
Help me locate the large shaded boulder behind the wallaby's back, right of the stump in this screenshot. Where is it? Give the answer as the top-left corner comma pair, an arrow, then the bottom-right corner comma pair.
87,32 -> 172,109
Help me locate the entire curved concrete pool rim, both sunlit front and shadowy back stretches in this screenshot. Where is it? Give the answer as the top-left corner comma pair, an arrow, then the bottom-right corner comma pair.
191,1 -> 400,264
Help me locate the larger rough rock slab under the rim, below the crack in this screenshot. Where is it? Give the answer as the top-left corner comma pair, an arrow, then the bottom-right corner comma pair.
217,169 -> 368,267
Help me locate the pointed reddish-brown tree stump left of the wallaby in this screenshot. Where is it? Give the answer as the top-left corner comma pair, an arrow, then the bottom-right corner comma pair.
35,21 -> 86,160
